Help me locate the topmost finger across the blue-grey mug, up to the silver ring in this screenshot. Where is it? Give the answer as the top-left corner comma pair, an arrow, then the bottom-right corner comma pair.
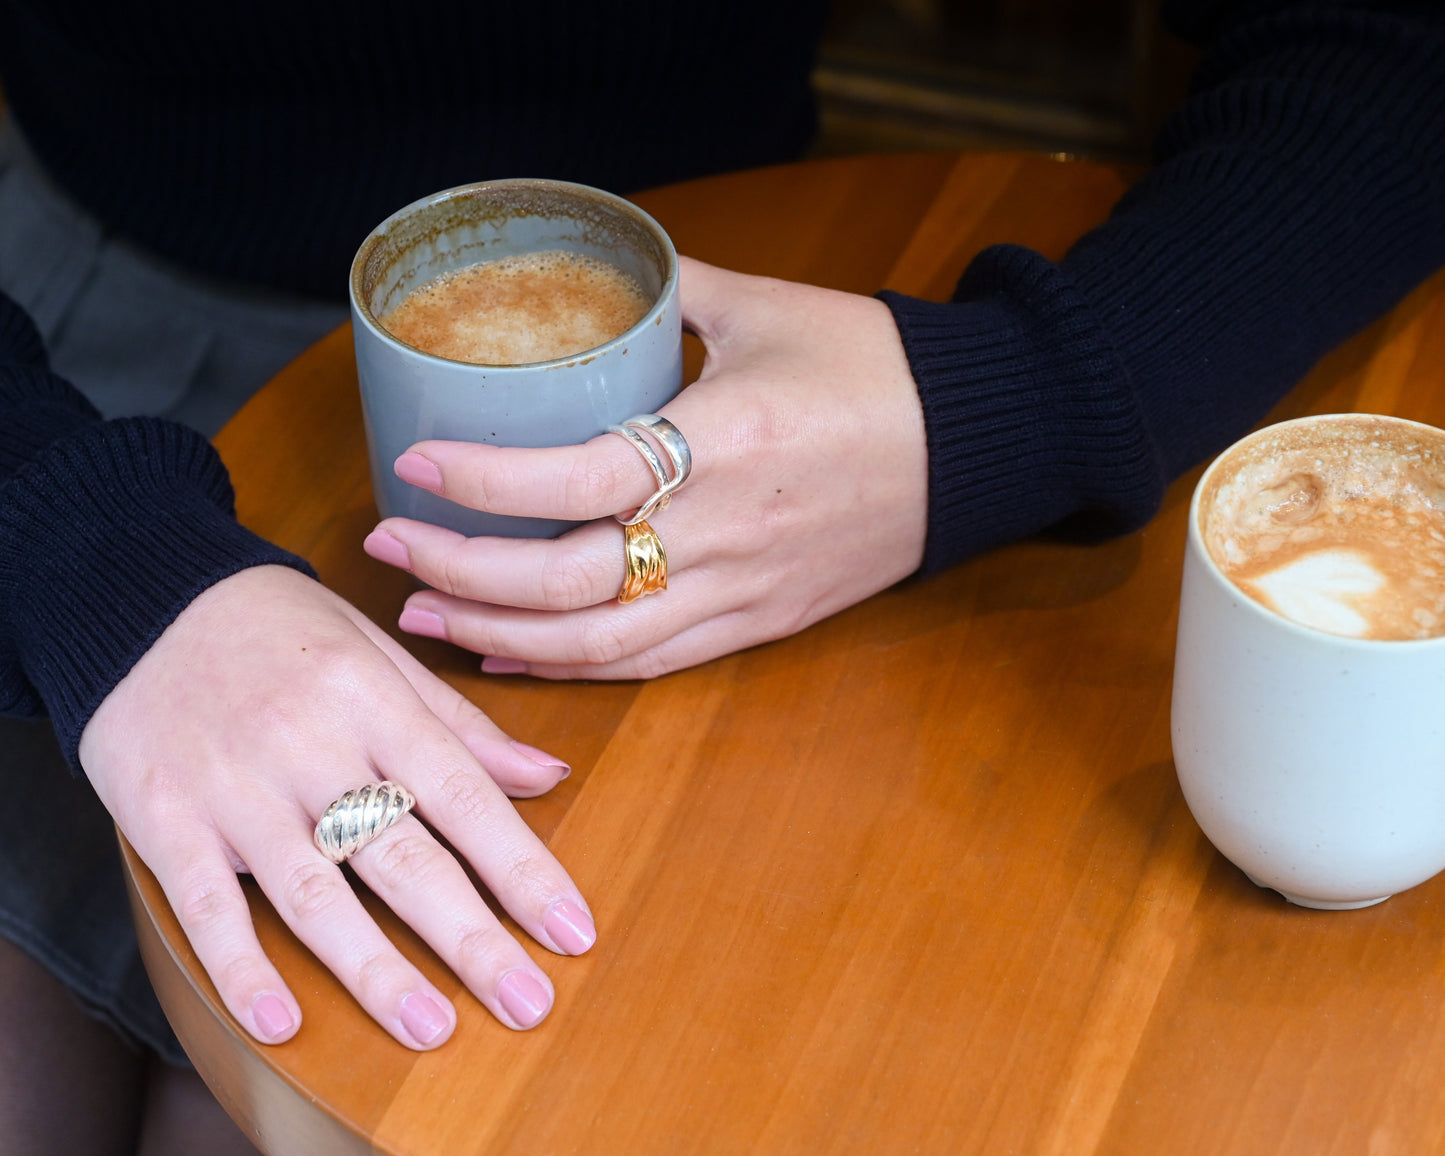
393,434 -> 656,522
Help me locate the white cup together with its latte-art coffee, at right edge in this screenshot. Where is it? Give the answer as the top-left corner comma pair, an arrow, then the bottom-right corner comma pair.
1172,413 -> 1445,909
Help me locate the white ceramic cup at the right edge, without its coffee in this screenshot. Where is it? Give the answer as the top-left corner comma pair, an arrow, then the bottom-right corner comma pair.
1172,415 -> 1445,909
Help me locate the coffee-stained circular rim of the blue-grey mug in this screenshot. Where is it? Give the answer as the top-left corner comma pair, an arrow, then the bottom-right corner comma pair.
347,176 -> 678,374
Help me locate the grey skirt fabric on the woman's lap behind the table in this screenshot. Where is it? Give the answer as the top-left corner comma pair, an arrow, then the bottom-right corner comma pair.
0,124 -> 346,1064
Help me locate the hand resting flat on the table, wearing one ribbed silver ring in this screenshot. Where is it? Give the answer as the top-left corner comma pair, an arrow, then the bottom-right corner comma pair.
79,566 -> 595,1049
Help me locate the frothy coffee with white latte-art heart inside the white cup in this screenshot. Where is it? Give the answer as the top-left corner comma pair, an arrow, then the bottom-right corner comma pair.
1199,415 -> 1445,640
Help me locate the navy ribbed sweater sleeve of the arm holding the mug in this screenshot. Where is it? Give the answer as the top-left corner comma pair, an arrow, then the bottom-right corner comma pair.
881,0 -> 1445,572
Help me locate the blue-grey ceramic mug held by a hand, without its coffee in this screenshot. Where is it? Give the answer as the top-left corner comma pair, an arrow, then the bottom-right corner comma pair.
351,179 -> 682,538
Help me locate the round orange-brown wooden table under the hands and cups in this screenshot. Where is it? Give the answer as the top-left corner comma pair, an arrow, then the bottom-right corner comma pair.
118,155 -> 1445,1156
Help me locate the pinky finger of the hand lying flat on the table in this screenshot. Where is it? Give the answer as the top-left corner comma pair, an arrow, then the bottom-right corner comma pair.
152,845 -> 301,1043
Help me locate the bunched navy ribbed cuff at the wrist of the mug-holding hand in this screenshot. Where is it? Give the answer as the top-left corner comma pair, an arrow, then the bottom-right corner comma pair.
879,246 -> 1163,574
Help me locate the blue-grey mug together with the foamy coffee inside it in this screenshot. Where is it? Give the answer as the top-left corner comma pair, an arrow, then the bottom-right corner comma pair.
351,178 -> 682,538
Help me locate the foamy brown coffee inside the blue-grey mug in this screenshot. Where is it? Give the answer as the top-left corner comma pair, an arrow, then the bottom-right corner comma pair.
380,249 -> 652,366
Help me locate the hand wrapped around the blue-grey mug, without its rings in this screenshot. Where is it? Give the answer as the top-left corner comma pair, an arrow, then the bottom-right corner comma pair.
366,259 -> 928,678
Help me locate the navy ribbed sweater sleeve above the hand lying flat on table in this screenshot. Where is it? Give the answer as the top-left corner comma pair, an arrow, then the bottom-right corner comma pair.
0,293 -> 311,766
